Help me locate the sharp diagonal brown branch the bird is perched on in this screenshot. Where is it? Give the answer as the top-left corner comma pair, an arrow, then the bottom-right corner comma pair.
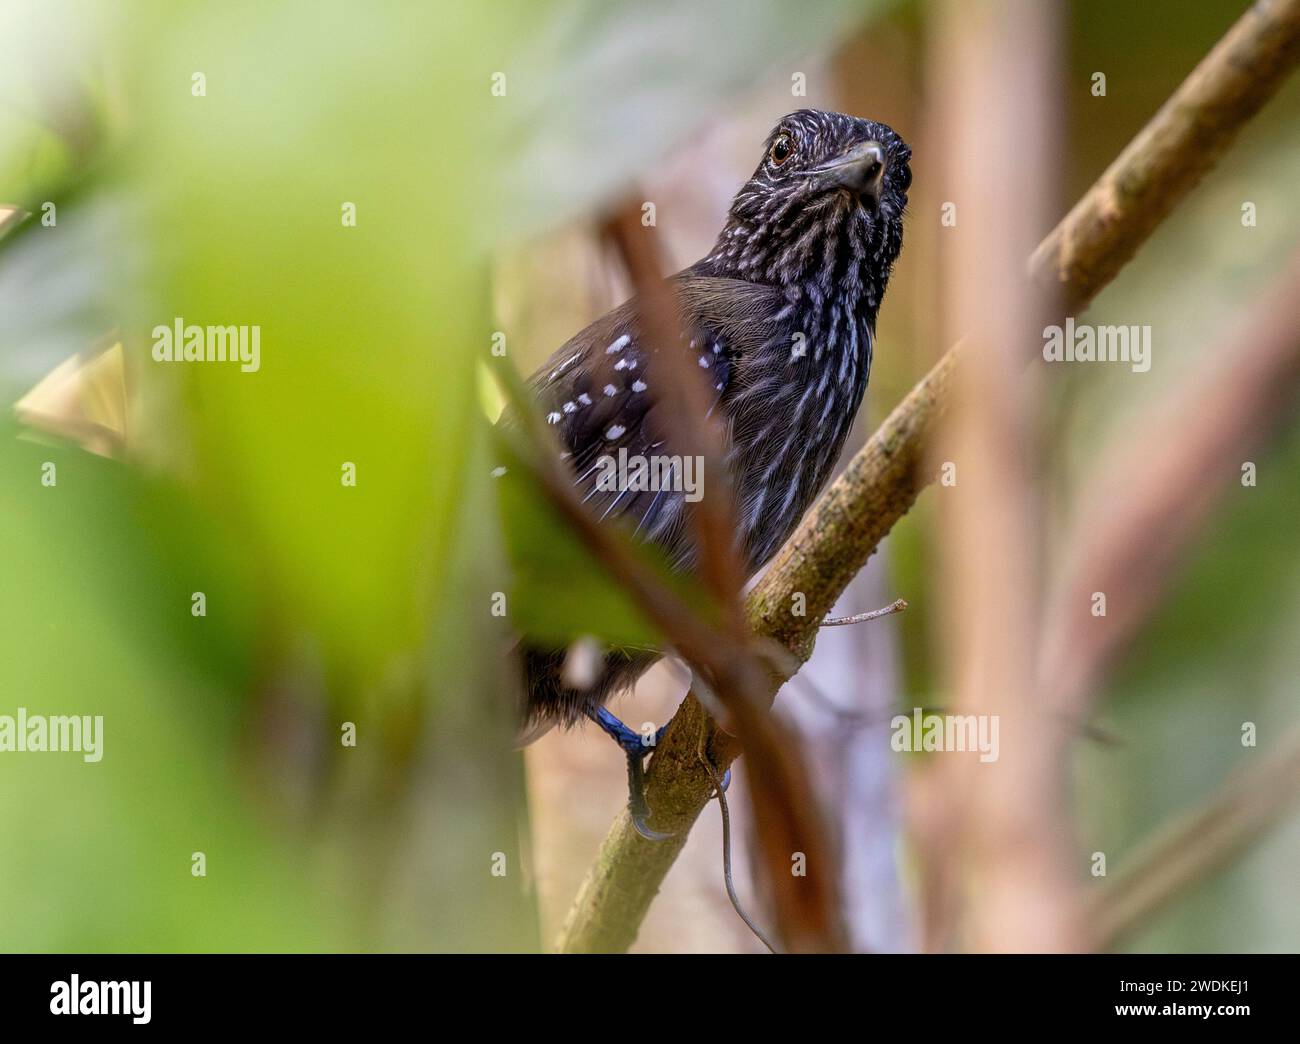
558,0 -> 1300,952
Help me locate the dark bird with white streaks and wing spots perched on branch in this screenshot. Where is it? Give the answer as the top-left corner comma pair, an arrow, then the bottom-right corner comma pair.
512,109 -> 911,839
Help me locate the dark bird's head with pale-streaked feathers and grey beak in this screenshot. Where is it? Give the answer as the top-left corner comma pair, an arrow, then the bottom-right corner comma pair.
710,109 -> 911,289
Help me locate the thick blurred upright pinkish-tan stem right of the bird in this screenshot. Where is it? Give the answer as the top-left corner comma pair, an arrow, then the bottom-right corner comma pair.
925,0 -> 1080,953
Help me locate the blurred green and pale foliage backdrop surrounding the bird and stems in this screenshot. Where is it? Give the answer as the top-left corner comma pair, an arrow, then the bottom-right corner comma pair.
0,0 -> 1300,952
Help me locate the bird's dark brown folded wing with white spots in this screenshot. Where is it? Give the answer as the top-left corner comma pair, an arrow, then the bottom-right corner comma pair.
530,272 -> 779,556
